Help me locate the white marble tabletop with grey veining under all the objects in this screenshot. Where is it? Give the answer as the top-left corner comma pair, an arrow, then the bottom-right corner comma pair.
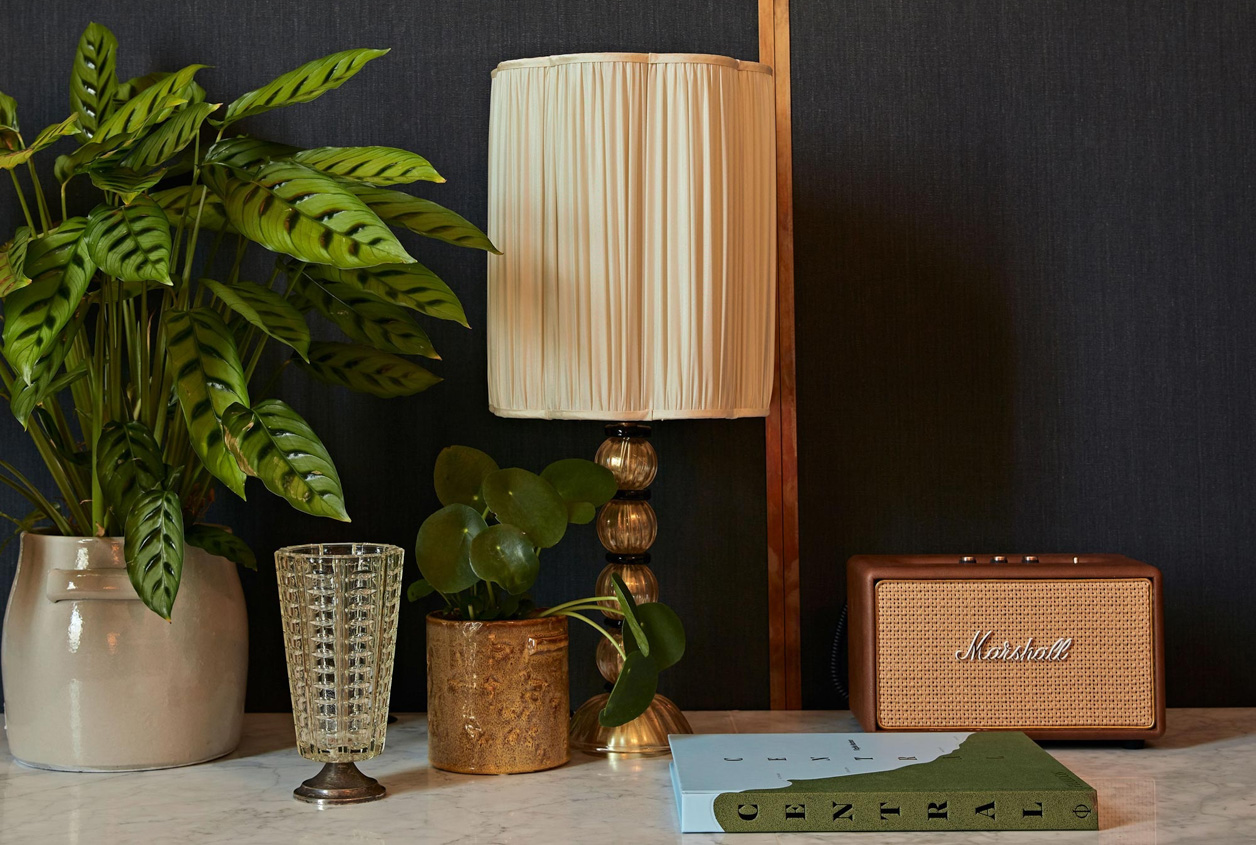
0,708 -> 1256,845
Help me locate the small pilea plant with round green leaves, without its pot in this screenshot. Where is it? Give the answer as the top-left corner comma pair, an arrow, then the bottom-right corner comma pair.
408,446 -> 685,727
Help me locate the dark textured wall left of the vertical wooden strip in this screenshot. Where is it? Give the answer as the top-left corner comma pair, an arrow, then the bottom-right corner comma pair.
0,0 -> 767,711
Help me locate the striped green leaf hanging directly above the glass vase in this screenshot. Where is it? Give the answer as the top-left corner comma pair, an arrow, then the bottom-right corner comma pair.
222,399 -> 349,522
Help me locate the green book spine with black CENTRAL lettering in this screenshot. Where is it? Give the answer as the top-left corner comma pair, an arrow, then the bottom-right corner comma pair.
713,790 -> 1099,832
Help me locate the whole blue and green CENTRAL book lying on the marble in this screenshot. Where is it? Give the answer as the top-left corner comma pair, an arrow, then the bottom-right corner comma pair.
671,731 -> 1099,834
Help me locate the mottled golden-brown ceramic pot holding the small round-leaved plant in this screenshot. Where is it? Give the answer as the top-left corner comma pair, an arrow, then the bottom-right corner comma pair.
427,613 -> 570,775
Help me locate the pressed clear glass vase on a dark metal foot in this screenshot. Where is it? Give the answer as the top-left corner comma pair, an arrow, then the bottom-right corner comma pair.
275,542 -> 404,804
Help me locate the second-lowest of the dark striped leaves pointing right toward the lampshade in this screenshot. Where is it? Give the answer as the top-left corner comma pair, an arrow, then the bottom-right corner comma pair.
294,276 -> 440,359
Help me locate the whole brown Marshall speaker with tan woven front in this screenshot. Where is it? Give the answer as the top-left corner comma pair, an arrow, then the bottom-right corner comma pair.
847,555 -> 1164,740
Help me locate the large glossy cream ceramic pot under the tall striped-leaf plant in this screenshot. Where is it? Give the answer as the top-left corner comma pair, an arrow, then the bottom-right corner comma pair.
0,534 -> 249,772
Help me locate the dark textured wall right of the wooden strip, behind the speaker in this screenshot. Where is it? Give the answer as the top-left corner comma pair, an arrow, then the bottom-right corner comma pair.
791,0 -> 1256,707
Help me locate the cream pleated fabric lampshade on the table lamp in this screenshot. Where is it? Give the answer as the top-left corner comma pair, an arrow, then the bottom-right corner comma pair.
487,53 -> 776,421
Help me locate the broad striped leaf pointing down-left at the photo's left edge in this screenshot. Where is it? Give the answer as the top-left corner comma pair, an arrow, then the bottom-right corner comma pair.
4,217 -> 95,384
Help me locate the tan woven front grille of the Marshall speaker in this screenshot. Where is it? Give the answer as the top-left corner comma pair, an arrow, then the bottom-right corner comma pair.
877,579 -> 1156,728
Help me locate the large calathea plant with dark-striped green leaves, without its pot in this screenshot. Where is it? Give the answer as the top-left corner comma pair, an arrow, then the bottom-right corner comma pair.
0,24 -> 494,618
